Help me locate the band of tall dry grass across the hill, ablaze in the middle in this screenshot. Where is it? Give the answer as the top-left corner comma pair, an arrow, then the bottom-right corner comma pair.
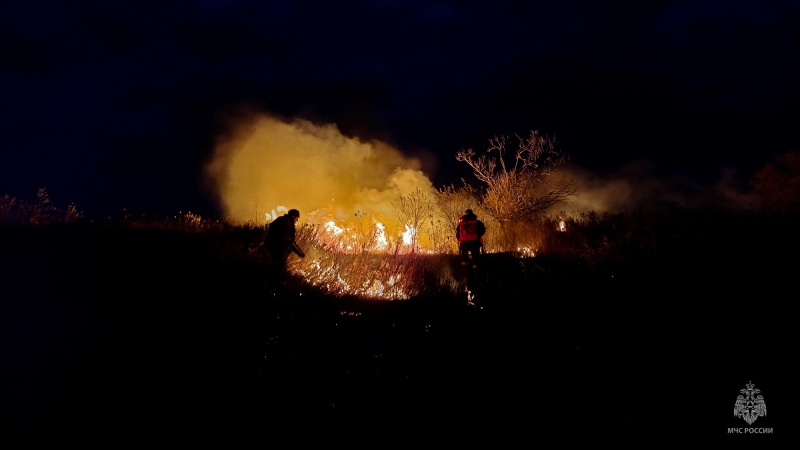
7,186 -> 798,301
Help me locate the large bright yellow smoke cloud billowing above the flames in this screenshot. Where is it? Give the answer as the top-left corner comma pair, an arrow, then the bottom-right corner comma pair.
206,114 -> 435,235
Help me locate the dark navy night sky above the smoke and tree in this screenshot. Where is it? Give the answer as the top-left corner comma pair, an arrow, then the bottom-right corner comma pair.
0,0 -> 800,215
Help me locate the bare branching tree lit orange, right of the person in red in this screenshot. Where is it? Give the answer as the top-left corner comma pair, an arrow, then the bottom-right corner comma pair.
456,130 -> 576,250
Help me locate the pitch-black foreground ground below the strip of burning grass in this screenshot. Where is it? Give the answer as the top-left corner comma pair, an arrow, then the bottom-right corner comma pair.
0,223 -> 800,447
